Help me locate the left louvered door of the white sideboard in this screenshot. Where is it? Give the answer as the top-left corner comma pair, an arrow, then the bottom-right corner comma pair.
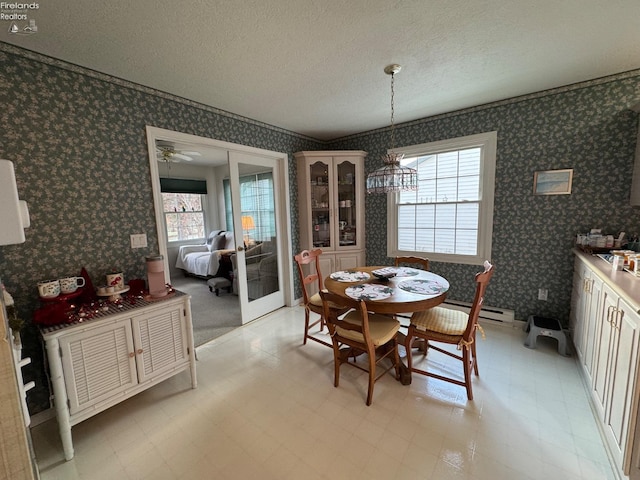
60,319 -> 138,416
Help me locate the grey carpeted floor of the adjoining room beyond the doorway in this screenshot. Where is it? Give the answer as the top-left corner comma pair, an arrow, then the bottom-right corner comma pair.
171,277 -> 242,347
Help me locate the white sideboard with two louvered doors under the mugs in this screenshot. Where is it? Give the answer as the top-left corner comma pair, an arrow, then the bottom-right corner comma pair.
41,292 -> 197,460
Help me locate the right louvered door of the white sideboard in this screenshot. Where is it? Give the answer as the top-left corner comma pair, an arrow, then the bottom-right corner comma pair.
131,304 -> 189,383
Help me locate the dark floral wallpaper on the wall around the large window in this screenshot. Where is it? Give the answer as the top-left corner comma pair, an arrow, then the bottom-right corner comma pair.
331,71 -> 640,326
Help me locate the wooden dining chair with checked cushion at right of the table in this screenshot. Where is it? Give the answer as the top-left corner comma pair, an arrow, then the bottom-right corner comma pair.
405,261 -> 494,400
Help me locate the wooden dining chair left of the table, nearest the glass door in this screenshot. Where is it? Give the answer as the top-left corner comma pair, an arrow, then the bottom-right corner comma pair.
293,248 -> 348,347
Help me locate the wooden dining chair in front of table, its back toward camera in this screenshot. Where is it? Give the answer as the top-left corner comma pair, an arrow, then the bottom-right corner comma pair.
320,291 -> 400,406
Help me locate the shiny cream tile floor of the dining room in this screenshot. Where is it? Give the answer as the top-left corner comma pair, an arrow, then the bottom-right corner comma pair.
32,307 -> 615,480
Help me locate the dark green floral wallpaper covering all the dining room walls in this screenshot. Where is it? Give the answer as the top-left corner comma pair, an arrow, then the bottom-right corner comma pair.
0,42 -> 640,413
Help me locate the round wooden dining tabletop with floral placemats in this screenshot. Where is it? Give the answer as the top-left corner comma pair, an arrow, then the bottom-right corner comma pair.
324,266 -> 449,314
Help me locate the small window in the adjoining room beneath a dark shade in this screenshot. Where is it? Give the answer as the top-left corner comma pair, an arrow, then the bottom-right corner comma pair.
162,192 -> 205,242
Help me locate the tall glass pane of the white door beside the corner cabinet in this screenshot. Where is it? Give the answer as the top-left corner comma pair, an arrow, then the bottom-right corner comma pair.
238,163 -> 280,302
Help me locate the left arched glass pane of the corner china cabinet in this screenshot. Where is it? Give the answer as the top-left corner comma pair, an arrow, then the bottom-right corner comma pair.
309,162 -> 332,248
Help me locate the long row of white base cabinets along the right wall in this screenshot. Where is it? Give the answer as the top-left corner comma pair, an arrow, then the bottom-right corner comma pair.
571,250 -> 640,478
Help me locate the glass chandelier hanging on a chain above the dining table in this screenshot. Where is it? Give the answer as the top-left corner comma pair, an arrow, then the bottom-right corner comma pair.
367,63 -> 418,193
